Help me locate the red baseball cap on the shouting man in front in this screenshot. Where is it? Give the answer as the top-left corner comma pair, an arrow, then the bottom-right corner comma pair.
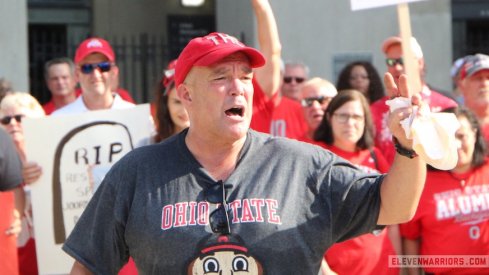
175,32 -> 265,87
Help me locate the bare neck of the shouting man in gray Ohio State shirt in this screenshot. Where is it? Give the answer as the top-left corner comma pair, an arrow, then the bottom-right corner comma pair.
185,129 -> 246,180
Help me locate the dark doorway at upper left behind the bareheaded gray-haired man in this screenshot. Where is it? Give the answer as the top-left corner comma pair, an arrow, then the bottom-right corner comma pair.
29,24 -> 68,104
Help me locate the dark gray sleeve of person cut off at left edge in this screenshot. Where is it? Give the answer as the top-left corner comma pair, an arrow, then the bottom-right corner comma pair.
0,129 -> 22,191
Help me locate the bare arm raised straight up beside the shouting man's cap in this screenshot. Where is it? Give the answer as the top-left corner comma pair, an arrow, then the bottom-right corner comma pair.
251,0 -> 282,97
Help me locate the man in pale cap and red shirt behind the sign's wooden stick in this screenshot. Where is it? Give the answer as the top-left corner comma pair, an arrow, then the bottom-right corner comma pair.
370,36 -> 457,163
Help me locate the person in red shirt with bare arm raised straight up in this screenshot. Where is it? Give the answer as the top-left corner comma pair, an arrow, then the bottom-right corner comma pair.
250,0 -> 307,139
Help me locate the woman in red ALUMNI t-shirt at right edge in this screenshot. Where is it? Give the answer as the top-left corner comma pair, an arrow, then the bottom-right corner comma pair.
400,108 -> 489,274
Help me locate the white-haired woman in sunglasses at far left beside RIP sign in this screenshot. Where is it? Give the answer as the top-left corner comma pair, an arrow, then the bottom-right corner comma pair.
0,92 -> 45,274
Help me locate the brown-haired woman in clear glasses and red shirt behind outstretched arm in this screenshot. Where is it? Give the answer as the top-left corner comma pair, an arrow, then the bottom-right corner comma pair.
314,90 -> 399,274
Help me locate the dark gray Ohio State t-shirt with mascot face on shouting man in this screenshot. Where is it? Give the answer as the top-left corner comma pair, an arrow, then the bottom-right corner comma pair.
63,130 -> 382,275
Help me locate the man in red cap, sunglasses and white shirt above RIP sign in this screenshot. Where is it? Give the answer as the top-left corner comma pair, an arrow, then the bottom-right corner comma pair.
53,37 -> 134,115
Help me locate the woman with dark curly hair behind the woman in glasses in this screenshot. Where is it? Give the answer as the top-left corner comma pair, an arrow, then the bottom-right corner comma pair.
336,61 -> 385,103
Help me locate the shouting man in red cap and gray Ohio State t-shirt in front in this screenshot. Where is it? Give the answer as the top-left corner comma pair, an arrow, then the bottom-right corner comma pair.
63,4 -> 426,274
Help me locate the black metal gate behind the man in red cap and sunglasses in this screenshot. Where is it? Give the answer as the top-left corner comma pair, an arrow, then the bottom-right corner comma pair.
29,25 -> 168,104
